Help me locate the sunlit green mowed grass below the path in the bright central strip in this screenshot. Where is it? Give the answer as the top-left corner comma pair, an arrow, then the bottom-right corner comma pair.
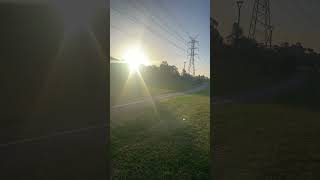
111,88 -> 210,180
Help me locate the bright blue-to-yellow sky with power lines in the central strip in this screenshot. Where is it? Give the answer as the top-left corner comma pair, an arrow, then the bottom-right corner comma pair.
110,0 -> 210,77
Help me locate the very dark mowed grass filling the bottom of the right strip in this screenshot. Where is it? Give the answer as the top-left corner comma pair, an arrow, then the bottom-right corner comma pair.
213,104 -> 320,180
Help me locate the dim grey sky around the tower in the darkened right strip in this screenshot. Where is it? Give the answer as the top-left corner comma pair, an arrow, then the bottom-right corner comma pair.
211,0 -> 320,52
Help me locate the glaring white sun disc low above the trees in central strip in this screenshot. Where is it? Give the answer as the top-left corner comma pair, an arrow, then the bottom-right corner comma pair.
123,46 -> 150,71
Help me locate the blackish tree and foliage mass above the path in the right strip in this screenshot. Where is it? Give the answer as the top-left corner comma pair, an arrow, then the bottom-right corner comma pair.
211,19 -> 320,96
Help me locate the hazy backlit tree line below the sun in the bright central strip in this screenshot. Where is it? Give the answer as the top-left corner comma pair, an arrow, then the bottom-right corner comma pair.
110,61 -> 210,93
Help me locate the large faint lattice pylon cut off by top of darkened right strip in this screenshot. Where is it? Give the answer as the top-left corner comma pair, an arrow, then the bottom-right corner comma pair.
249,0 -> 273,47
